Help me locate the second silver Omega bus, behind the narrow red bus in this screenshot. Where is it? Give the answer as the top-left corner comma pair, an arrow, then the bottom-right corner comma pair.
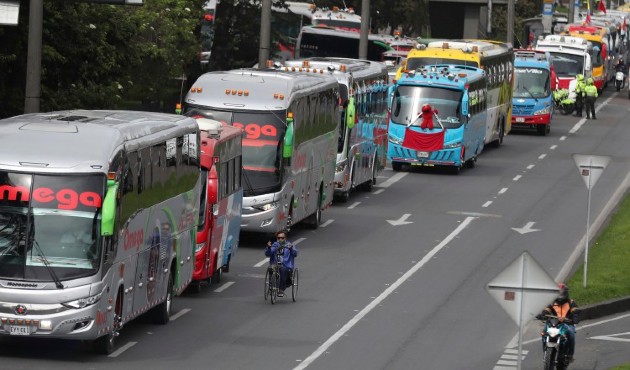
185,69 -> 339,233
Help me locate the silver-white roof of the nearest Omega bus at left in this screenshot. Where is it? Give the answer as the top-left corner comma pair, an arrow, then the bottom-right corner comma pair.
0,110 -> 197,173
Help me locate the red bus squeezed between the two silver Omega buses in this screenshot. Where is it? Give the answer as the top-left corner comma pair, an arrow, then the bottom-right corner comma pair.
188,117 -> 243,292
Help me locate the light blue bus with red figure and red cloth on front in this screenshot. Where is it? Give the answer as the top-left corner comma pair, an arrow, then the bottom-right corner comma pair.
387,65 -> 488,174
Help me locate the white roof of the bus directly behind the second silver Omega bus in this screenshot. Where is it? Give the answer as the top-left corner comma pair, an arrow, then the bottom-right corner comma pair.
283,57 -> 387,82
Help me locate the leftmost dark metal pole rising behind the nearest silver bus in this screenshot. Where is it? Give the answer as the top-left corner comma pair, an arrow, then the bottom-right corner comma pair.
24,0 -> 44,113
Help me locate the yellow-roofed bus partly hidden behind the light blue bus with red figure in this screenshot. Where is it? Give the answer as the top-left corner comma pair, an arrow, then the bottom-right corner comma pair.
400,40 -> 514,147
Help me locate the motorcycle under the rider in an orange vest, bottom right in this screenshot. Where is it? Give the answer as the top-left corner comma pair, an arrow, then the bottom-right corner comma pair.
541,315 -> 571,370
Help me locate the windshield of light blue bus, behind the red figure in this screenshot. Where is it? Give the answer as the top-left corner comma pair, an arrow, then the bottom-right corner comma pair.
391,85 -> 463,128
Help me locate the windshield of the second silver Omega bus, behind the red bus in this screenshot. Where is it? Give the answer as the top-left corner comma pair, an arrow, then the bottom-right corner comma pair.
186,108 -> 286,196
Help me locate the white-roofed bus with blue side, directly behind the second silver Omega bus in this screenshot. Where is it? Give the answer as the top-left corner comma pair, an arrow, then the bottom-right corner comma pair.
281,58 -> 389,202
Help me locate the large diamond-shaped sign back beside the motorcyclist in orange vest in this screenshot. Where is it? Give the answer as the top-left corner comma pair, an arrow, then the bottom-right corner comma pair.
486,252 -> 559,327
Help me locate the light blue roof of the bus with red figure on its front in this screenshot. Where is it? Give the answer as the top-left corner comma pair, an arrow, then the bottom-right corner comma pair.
396,64 -> 486,90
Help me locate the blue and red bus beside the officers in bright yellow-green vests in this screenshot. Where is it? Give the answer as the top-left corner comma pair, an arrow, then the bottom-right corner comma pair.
512,50 -> 554,136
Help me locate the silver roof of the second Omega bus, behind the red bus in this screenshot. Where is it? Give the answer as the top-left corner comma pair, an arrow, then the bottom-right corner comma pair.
186,69 -> 337,111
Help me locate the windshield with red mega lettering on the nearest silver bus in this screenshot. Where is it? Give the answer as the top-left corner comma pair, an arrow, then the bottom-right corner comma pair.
0,171 -> 105,282
